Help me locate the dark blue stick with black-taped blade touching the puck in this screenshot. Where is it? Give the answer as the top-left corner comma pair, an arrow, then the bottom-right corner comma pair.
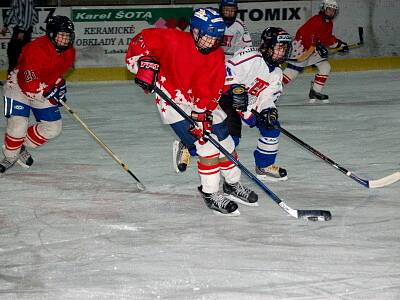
154,86 -> 332,221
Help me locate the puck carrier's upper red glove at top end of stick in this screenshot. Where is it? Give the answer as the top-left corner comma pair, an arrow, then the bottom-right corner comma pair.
135,56 -> 160,93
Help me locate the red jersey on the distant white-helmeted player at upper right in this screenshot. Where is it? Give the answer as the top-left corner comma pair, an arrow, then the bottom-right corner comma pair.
295,14 -> 337,50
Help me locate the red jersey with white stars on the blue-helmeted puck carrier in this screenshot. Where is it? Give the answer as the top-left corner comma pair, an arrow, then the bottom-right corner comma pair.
126,28 -> 225,110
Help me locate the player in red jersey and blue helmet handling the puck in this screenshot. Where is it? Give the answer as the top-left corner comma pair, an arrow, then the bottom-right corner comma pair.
126,8 -> 258,216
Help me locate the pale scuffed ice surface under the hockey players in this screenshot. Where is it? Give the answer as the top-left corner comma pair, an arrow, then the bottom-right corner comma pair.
0,71 -> 400,300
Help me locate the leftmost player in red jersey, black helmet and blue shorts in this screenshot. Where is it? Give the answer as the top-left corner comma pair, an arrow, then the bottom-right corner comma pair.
0,16 -> 75,173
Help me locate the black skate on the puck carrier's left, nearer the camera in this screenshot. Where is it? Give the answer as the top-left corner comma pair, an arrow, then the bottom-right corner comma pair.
198,186 -> 240,217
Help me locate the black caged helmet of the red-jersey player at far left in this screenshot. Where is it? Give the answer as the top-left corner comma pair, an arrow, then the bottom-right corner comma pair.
46,16 -> 75,52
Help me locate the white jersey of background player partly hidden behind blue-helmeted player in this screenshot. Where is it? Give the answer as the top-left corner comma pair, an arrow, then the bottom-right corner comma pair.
222,18 -> 252,60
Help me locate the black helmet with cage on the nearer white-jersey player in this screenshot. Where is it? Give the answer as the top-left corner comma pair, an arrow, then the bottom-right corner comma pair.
259,27 -> 292,67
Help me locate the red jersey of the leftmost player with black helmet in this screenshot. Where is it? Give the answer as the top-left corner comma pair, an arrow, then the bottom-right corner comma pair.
17,36 -> 75,95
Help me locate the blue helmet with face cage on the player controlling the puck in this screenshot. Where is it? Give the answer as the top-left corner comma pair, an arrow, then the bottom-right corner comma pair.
190,8 -> 225,54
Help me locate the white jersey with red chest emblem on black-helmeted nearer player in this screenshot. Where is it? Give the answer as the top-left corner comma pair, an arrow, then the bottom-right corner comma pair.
225,47 -> 282,119
